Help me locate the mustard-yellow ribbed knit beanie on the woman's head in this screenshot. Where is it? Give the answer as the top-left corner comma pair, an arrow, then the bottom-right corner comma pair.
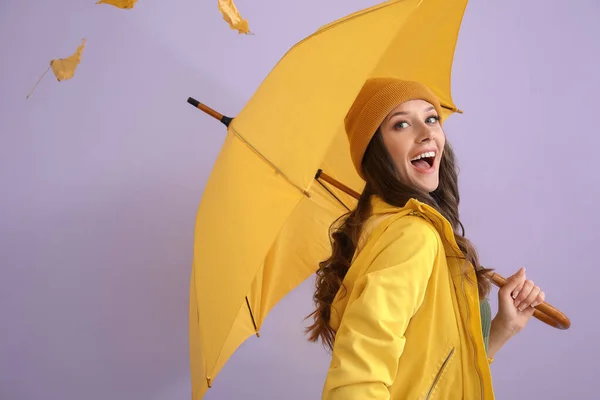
344,78 -> 442,179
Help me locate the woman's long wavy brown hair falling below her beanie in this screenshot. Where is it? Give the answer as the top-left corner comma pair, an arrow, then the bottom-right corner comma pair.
306,130 -> 490,350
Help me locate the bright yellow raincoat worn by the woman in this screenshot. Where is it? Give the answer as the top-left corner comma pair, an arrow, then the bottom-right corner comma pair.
322,197 -> 494,400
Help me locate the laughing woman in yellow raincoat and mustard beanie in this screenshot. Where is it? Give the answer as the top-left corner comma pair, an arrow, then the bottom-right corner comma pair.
308,78 -> 544,400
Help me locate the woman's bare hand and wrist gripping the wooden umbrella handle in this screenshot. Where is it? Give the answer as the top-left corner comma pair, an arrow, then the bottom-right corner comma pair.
488,268 -> 545,358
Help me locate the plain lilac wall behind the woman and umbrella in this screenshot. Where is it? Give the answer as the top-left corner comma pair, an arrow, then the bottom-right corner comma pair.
0,0 -> 600,400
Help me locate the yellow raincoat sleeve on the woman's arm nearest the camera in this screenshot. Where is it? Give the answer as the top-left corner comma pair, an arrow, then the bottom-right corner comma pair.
322,217 -> 439,400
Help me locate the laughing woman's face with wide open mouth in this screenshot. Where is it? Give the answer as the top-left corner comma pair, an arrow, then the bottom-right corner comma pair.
381,100 -> 446,193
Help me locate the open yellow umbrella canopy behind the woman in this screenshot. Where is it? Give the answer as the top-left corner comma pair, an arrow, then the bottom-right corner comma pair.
190,0 -> 467,399
